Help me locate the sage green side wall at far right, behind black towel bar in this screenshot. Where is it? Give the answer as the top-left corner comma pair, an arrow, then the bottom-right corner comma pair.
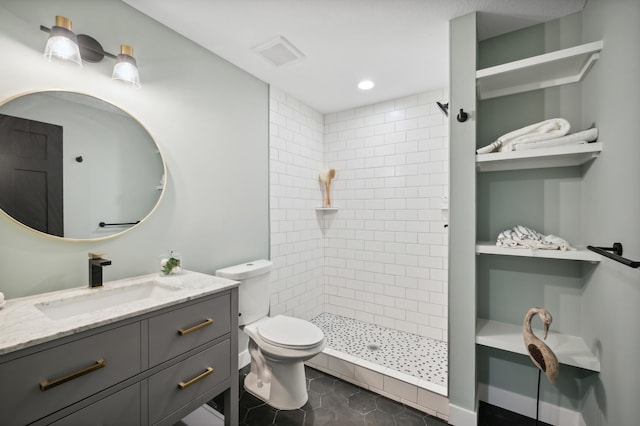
582,0 -> 640,426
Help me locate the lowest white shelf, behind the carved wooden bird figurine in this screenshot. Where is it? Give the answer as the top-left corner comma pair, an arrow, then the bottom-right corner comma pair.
476,318 -> 600,372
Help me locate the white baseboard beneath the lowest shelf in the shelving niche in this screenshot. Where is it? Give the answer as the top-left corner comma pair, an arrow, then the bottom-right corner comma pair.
478,383 -> 585,426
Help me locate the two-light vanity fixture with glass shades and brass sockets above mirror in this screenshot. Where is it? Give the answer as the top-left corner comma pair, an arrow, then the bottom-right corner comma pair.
40,16 -> 140,87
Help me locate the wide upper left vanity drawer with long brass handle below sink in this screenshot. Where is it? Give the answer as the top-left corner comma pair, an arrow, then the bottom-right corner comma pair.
0,323 -> 141,425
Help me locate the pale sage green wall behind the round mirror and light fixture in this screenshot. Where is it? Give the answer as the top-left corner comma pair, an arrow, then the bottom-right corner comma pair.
0,0 -> 269,298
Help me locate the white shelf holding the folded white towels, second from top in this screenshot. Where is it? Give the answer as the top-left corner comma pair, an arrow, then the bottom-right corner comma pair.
476,142 -> 602,172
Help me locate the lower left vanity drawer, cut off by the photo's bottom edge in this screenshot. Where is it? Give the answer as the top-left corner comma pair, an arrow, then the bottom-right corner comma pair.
51,383 -> 142,426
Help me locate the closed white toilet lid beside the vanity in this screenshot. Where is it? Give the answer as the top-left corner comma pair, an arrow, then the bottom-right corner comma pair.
258,315 -> 324,349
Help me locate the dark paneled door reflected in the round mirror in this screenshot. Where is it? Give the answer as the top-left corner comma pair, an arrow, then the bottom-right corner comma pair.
0,114 -> 64,237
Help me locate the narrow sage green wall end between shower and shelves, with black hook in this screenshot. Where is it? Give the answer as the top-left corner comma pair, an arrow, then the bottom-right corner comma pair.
449,13 -> 477,425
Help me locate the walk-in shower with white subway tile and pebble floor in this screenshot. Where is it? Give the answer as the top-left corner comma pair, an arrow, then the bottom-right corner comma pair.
270,88 -> 449,418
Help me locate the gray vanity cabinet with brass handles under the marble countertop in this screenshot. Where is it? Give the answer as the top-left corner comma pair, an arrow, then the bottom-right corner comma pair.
0,288 -> 238,426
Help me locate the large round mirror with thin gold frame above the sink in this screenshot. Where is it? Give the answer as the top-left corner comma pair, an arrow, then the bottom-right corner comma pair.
0,91 -> 166,240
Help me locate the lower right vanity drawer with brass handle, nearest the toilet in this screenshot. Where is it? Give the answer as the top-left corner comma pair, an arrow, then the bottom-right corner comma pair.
149,340 -> 231,424
